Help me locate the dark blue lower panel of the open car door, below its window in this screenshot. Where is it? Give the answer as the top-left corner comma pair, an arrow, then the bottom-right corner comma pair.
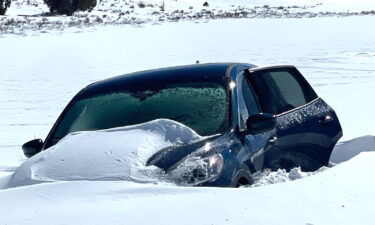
264,98 -> 342,171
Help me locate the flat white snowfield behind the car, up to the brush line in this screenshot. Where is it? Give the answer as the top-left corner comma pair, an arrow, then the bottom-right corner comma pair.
0,17 -> 375,168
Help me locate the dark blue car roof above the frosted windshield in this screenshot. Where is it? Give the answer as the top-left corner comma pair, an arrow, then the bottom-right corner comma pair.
76,63 -> 254,98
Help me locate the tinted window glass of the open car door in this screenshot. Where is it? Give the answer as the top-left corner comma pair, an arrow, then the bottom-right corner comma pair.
248,68 -> 317,114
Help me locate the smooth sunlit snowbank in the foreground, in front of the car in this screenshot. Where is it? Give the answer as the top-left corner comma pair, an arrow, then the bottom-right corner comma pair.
0,152 -> 375,225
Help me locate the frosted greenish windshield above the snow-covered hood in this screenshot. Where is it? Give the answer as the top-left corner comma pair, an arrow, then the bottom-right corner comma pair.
52,82 -> 228,146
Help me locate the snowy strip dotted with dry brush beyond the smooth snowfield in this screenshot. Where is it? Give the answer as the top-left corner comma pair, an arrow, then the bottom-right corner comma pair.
0,0 -> 375,37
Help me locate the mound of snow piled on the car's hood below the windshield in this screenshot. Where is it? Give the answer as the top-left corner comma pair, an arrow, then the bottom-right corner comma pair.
8,119 -> 201,187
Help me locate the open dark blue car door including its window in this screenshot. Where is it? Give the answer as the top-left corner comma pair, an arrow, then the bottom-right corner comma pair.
246,66 -> 342,171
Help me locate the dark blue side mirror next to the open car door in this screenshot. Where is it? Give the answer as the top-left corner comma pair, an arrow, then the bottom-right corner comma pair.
246,113 -> 276,134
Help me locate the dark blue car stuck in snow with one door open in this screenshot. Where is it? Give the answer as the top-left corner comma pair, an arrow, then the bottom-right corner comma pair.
22,63 -> 342,187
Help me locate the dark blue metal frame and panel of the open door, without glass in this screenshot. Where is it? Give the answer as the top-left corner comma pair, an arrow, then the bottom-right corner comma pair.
244,65 -> 342,171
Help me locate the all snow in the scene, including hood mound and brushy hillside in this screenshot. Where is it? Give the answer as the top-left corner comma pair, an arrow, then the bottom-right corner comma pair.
0,0 -> 375,225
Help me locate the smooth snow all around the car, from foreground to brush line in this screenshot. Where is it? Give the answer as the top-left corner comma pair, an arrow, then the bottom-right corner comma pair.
0,1 -> 375,225
